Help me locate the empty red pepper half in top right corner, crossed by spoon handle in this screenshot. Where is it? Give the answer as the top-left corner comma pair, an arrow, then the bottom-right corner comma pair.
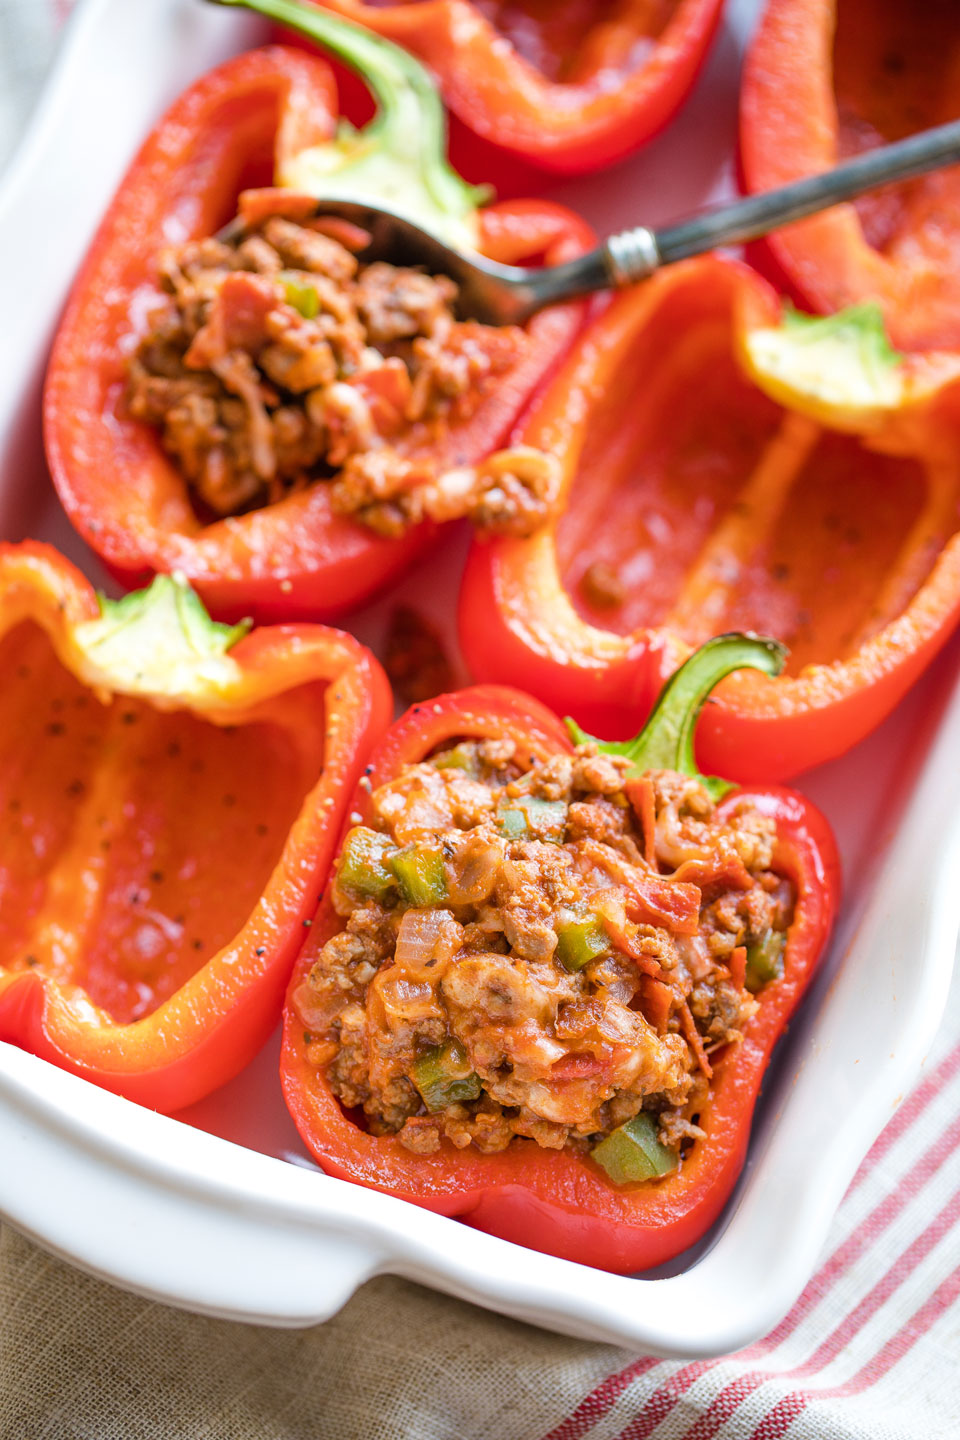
740,0 -> 960,350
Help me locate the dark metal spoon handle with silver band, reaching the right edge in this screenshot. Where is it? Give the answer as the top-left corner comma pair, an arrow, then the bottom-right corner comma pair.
541,120 -> 960,304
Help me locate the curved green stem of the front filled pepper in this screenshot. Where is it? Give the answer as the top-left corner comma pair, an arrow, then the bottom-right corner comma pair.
564,634 -> 787,799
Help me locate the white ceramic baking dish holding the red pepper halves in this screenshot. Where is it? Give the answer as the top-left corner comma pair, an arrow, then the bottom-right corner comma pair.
0,0 -> 960,1356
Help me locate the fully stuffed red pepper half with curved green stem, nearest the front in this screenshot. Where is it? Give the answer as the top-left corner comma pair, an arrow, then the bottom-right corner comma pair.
282,635 -> 838,1272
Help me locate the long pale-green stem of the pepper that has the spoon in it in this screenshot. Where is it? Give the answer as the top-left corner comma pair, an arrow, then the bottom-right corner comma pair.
204,0 -> 492,249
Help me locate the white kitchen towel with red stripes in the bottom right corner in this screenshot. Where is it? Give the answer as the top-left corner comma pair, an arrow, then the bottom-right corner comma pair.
544,982 -> 960,1440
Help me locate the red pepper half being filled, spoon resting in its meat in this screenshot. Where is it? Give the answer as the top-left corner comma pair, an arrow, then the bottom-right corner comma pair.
45,7 -> 590,619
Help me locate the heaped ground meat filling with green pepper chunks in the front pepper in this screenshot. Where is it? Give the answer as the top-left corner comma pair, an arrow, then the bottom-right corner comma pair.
294,740 -> 794,1153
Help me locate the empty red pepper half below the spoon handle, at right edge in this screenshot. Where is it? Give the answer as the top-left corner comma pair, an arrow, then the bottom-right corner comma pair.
459,256 -> 960,782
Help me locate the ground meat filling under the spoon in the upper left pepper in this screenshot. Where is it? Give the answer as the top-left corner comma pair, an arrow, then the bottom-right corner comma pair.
127,205 -> 560,537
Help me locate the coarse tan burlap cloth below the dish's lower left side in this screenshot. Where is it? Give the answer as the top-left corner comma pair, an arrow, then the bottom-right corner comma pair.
0,1228 -> 623,1440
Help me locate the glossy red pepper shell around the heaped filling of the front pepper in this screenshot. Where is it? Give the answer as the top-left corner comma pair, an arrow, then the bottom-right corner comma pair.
281,673 -> 838,1273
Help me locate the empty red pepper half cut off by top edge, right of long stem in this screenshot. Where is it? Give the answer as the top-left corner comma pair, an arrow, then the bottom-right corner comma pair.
303,0 -> 723,174
